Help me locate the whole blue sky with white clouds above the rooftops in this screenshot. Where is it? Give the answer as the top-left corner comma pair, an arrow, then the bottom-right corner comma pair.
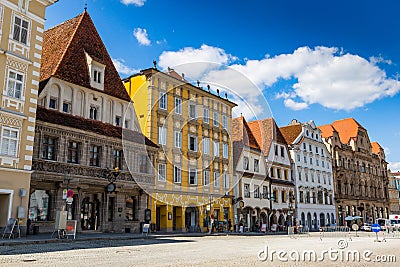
46,0 -> 400,170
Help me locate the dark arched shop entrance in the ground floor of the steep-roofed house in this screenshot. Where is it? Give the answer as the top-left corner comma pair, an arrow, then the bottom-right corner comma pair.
81,195 -> 100,230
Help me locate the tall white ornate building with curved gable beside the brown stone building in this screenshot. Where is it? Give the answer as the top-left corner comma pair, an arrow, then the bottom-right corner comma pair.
280,120 -> 336,230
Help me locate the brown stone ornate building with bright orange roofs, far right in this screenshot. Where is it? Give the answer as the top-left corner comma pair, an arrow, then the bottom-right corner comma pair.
319,118 -> 389,225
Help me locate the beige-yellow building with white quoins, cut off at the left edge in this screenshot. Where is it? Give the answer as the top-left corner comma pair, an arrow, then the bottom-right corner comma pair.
0,0 -> 57,232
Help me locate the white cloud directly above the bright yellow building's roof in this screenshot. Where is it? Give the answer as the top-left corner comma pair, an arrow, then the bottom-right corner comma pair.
158,44 -> 236,80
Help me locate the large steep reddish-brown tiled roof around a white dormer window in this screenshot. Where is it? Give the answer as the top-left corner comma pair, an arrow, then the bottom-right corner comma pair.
39,11 -> 130,101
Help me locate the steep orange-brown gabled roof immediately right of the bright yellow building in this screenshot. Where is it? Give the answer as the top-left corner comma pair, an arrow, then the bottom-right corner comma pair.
232,116 -> 261,151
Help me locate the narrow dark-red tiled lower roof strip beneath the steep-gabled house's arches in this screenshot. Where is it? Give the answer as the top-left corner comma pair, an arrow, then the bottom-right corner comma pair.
36,106 -> 158,147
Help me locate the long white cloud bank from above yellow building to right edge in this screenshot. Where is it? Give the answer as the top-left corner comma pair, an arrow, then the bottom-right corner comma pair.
159,45 -> 400,115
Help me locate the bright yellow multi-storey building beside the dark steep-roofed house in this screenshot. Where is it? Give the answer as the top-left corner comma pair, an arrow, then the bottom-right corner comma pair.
124,67 -> 236,231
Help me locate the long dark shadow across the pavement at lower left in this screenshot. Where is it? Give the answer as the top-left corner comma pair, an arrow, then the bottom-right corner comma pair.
0,238 -> 195,256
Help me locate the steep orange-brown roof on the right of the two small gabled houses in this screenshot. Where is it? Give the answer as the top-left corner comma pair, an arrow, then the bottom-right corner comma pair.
248,118 -> 287,156
